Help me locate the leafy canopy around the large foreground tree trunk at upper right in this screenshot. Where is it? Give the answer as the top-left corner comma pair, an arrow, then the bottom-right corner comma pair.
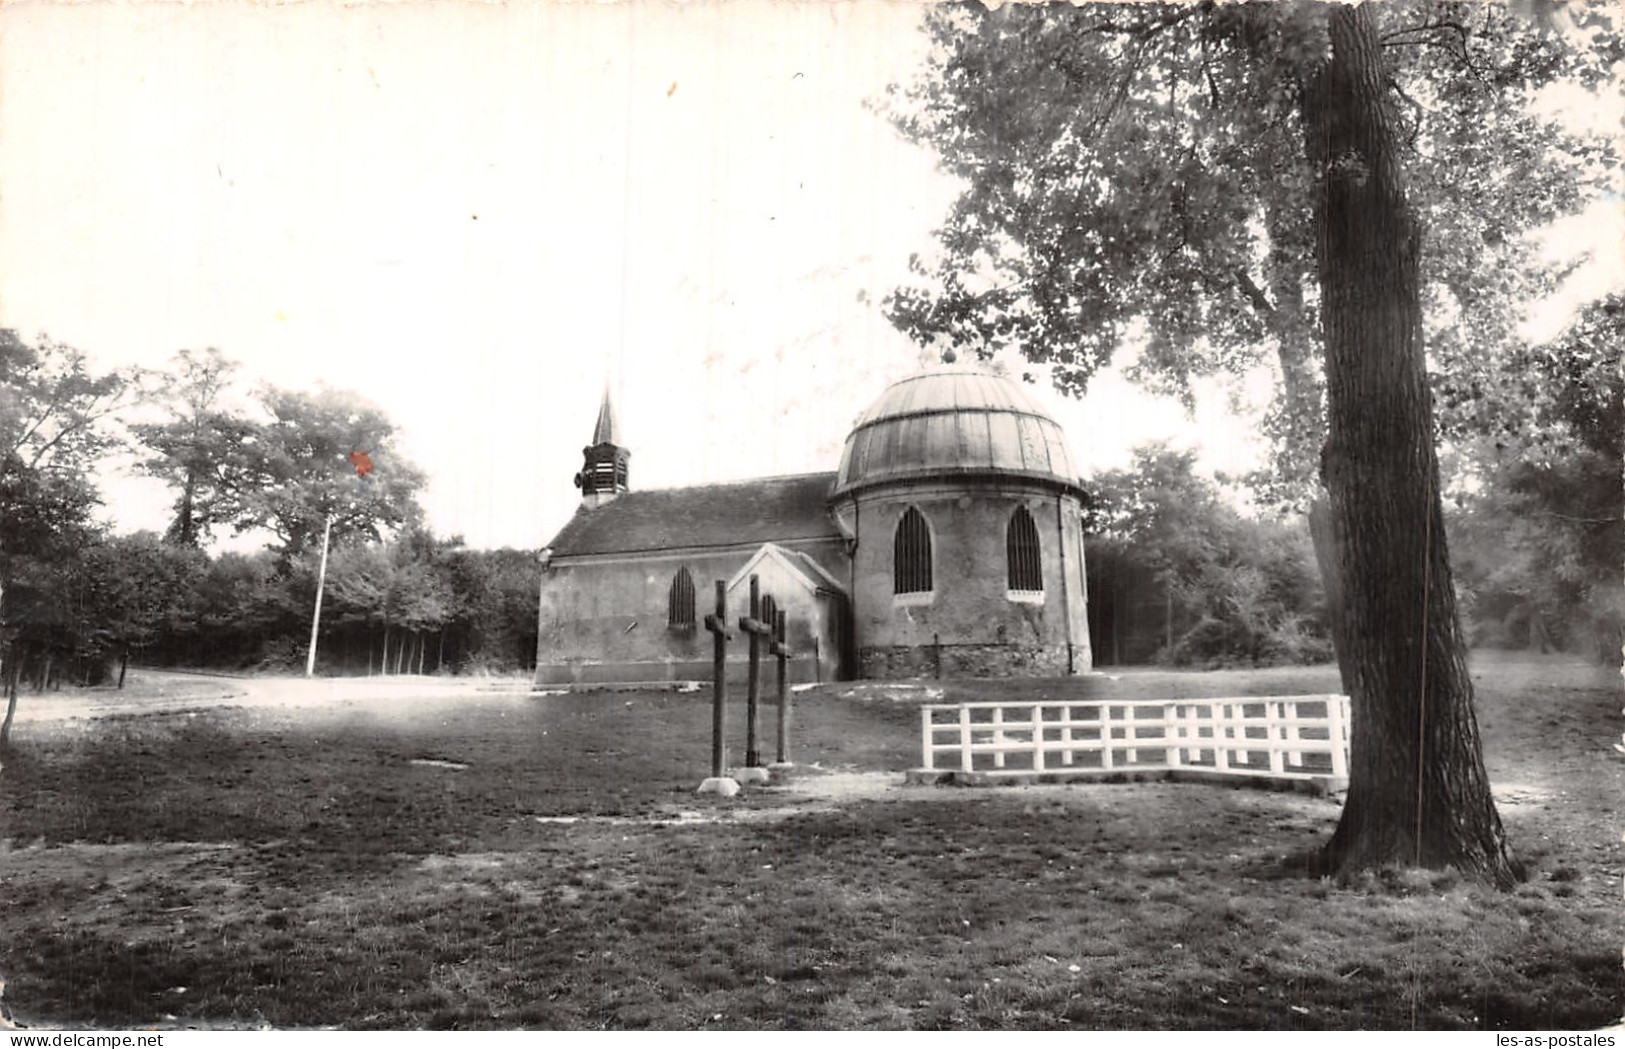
887,2 -> 1620,505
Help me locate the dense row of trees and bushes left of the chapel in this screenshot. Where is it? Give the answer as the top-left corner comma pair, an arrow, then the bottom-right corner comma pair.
0,331 -> 540,739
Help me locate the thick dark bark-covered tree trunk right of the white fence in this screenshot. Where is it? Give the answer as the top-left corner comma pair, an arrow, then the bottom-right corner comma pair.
1305,3 -> 1521,887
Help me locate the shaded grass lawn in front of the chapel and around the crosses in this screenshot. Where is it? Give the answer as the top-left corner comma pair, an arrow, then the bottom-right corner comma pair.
0,654 -> 1625,1030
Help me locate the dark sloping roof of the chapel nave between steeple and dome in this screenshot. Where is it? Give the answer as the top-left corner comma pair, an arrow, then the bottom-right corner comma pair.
549,473 -> 840,557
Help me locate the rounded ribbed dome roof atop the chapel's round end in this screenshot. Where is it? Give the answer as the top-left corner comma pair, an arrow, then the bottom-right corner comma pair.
834,365 -> 1077,495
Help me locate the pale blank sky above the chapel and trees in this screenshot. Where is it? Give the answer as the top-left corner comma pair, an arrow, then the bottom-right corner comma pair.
0,0 -> 1612,547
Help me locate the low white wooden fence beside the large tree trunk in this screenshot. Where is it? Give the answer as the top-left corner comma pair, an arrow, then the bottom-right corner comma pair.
920,695 -> 1349,779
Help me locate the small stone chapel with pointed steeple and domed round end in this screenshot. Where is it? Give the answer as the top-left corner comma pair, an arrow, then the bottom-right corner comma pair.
536,364 -> 1090,685
